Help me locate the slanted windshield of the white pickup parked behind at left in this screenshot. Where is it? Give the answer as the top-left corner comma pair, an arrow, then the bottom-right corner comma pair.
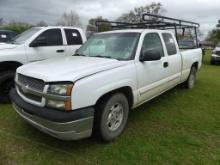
11,27 -> 41,44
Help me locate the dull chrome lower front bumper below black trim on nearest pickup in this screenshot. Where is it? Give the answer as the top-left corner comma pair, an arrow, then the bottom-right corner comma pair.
12,103 -> 93,140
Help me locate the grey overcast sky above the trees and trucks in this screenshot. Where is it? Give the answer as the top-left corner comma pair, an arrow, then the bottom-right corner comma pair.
0,0 -> 220,38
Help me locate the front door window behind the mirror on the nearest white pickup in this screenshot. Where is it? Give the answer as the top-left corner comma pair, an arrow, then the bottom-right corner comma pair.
142,33 -> 164,57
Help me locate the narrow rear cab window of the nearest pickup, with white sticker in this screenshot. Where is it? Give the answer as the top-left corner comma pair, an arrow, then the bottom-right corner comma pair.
162,33 -> 177,56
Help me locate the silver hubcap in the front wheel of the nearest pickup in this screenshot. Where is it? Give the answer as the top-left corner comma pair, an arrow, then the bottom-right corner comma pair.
107,103 -> 124,131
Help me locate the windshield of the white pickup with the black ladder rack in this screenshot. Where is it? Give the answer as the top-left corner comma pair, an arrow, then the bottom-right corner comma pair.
75,33 -> 140,60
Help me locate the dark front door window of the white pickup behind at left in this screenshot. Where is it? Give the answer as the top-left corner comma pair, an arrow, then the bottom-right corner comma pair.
36,29 -> 63,46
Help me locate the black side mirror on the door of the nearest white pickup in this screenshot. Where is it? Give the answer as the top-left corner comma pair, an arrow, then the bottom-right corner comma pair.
140,50 -> 161,62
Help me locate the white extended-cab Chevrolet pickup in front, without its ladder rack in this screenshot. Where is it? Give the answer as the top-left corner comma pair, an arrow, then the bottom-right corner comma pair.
10,29 -> 202,141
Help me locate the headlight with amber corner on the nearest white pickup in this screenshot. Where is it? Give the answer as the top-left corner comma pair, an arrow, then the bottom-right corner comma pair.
47,84 -> 73,111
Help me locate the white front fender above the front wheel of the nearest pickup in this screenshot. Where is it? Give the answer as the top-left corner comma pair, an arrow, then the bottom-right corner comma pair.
72,64 -> 137,109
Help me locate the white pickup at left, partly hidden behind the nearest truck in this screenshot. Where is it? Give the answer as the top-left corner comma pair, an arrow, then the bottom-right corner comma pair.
0,26 -> 86,102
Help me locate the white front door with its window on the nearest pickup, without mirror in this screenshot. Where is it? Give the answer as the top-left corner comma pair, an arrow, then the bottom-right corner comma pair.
136,33 -> 166,103
